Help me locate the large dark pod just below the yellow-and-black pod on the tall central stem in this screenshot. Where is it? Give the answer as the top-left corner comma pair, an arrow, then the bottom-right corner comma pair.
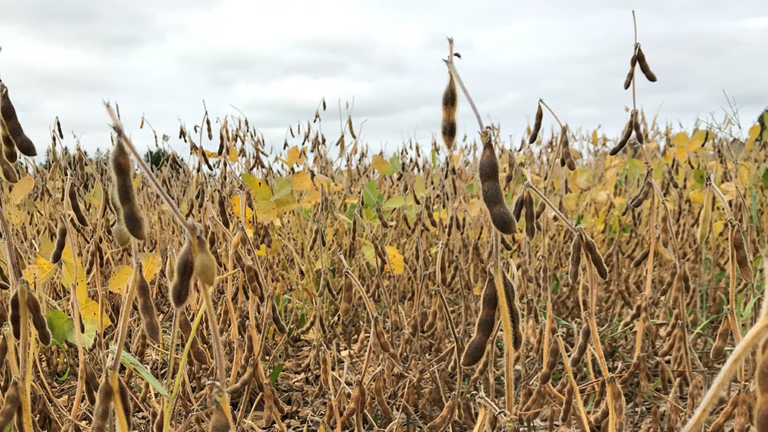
480,128 -> 517,235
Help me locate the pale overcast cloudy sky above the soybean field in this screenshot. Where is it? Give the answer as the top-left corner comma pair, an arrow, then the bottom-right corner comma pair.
0,0 -> 768,160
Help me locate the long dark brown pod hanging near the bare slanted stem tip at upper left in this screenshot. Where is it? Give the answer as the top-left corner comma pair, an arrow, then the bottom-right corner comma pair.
110,138 -> 146,240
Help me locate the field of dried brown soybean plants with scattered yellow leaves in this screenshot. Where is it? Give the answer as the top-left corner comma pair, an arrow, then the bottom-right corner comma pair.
0,30 -> 768,432
